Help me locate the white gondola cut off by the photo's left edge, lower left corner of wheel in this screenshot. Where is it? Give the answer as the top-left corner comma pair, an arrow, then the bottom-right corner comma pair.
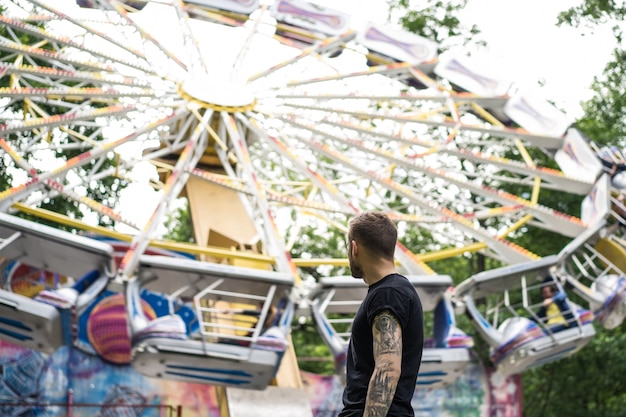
0,213 -> 113,353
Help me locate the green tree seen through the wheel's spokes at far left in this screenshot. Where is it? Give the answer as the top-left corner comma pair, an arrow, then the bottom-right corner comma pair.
0,3 -> 128,229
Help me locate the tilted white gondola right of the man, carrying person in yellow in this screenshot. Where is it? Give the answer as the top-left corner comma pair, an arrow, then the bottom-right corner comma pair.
454,255 -> 595,375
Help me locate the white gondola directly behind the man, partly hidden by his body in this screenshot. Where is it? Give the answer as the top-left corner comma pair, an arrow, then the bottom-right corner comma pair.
310,275 -> 473,388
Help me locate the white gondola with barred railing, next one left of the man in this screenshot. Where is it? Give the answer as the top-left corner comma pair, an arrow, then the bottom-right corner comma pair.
127,255 -> 294,389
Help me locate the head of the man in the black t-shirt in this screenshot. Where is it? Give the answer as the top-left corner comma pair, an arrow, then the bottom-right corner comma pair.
348,212 -> 398,278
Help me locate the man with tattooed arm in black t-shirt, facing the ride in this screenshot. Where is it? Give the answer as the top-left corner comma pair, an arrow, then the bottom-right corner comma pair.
339,212 -> 424,417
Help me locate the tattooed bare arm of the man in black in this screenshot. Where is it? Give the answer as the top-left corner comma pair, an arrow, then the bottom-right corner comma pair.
363,310 -> 402,417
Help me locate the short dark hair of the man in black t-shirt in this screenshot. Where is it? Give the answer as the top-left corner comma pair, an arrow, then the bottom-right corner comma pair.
348,211 -> 398,260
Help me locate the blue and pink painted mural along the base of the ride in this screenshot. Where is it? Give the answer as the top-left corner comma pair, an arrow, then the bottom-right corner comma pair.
0,341 -> 522,417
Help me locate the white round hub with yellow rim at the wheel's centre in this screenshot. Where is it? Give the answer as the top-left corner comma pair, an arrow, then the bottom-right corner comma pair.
179,76 -> 256,112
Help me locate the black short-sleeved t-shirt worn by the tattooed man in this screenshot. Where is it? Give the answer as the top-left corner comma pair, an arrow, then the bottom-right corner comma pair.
339,274 -> 424,417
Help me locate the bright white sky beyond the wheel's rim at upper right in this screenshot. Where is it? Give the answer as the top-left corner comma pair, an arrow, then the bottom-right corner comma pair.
315,0 -> 616,117
